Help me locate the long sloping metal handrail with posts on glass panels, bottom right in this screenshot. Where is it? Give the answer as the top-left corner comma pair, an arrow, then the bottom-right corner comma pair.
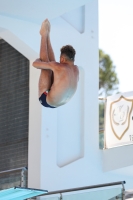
40,181 -> 126,200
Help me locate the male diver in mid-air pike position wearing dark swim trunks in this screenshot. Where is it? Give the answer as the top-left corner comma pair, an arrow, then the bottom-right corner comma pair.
33,19 -> 79,108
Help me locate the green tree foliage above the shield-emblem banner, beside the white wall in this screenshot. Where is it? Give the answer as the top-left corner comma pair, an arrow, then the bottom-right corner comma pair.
99,49 -> 119,96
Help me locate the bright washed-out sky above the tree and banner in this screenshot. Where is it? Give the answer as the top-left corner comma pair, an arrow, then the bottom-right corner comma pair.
99,0 -> 133,92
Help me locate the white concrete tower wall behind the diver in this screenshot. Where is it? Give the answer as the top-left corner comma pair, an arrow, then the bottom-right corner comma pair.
0,0 -> 133,190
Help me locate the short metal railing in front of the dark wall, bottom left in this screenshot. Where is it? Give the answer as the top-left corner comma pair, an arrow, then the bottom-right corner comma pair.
0,167 -> 28,187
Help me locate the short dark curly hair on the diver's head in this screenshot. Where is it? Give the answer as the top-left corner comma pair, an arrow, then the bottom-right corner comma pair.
60,45 -> 76,61
